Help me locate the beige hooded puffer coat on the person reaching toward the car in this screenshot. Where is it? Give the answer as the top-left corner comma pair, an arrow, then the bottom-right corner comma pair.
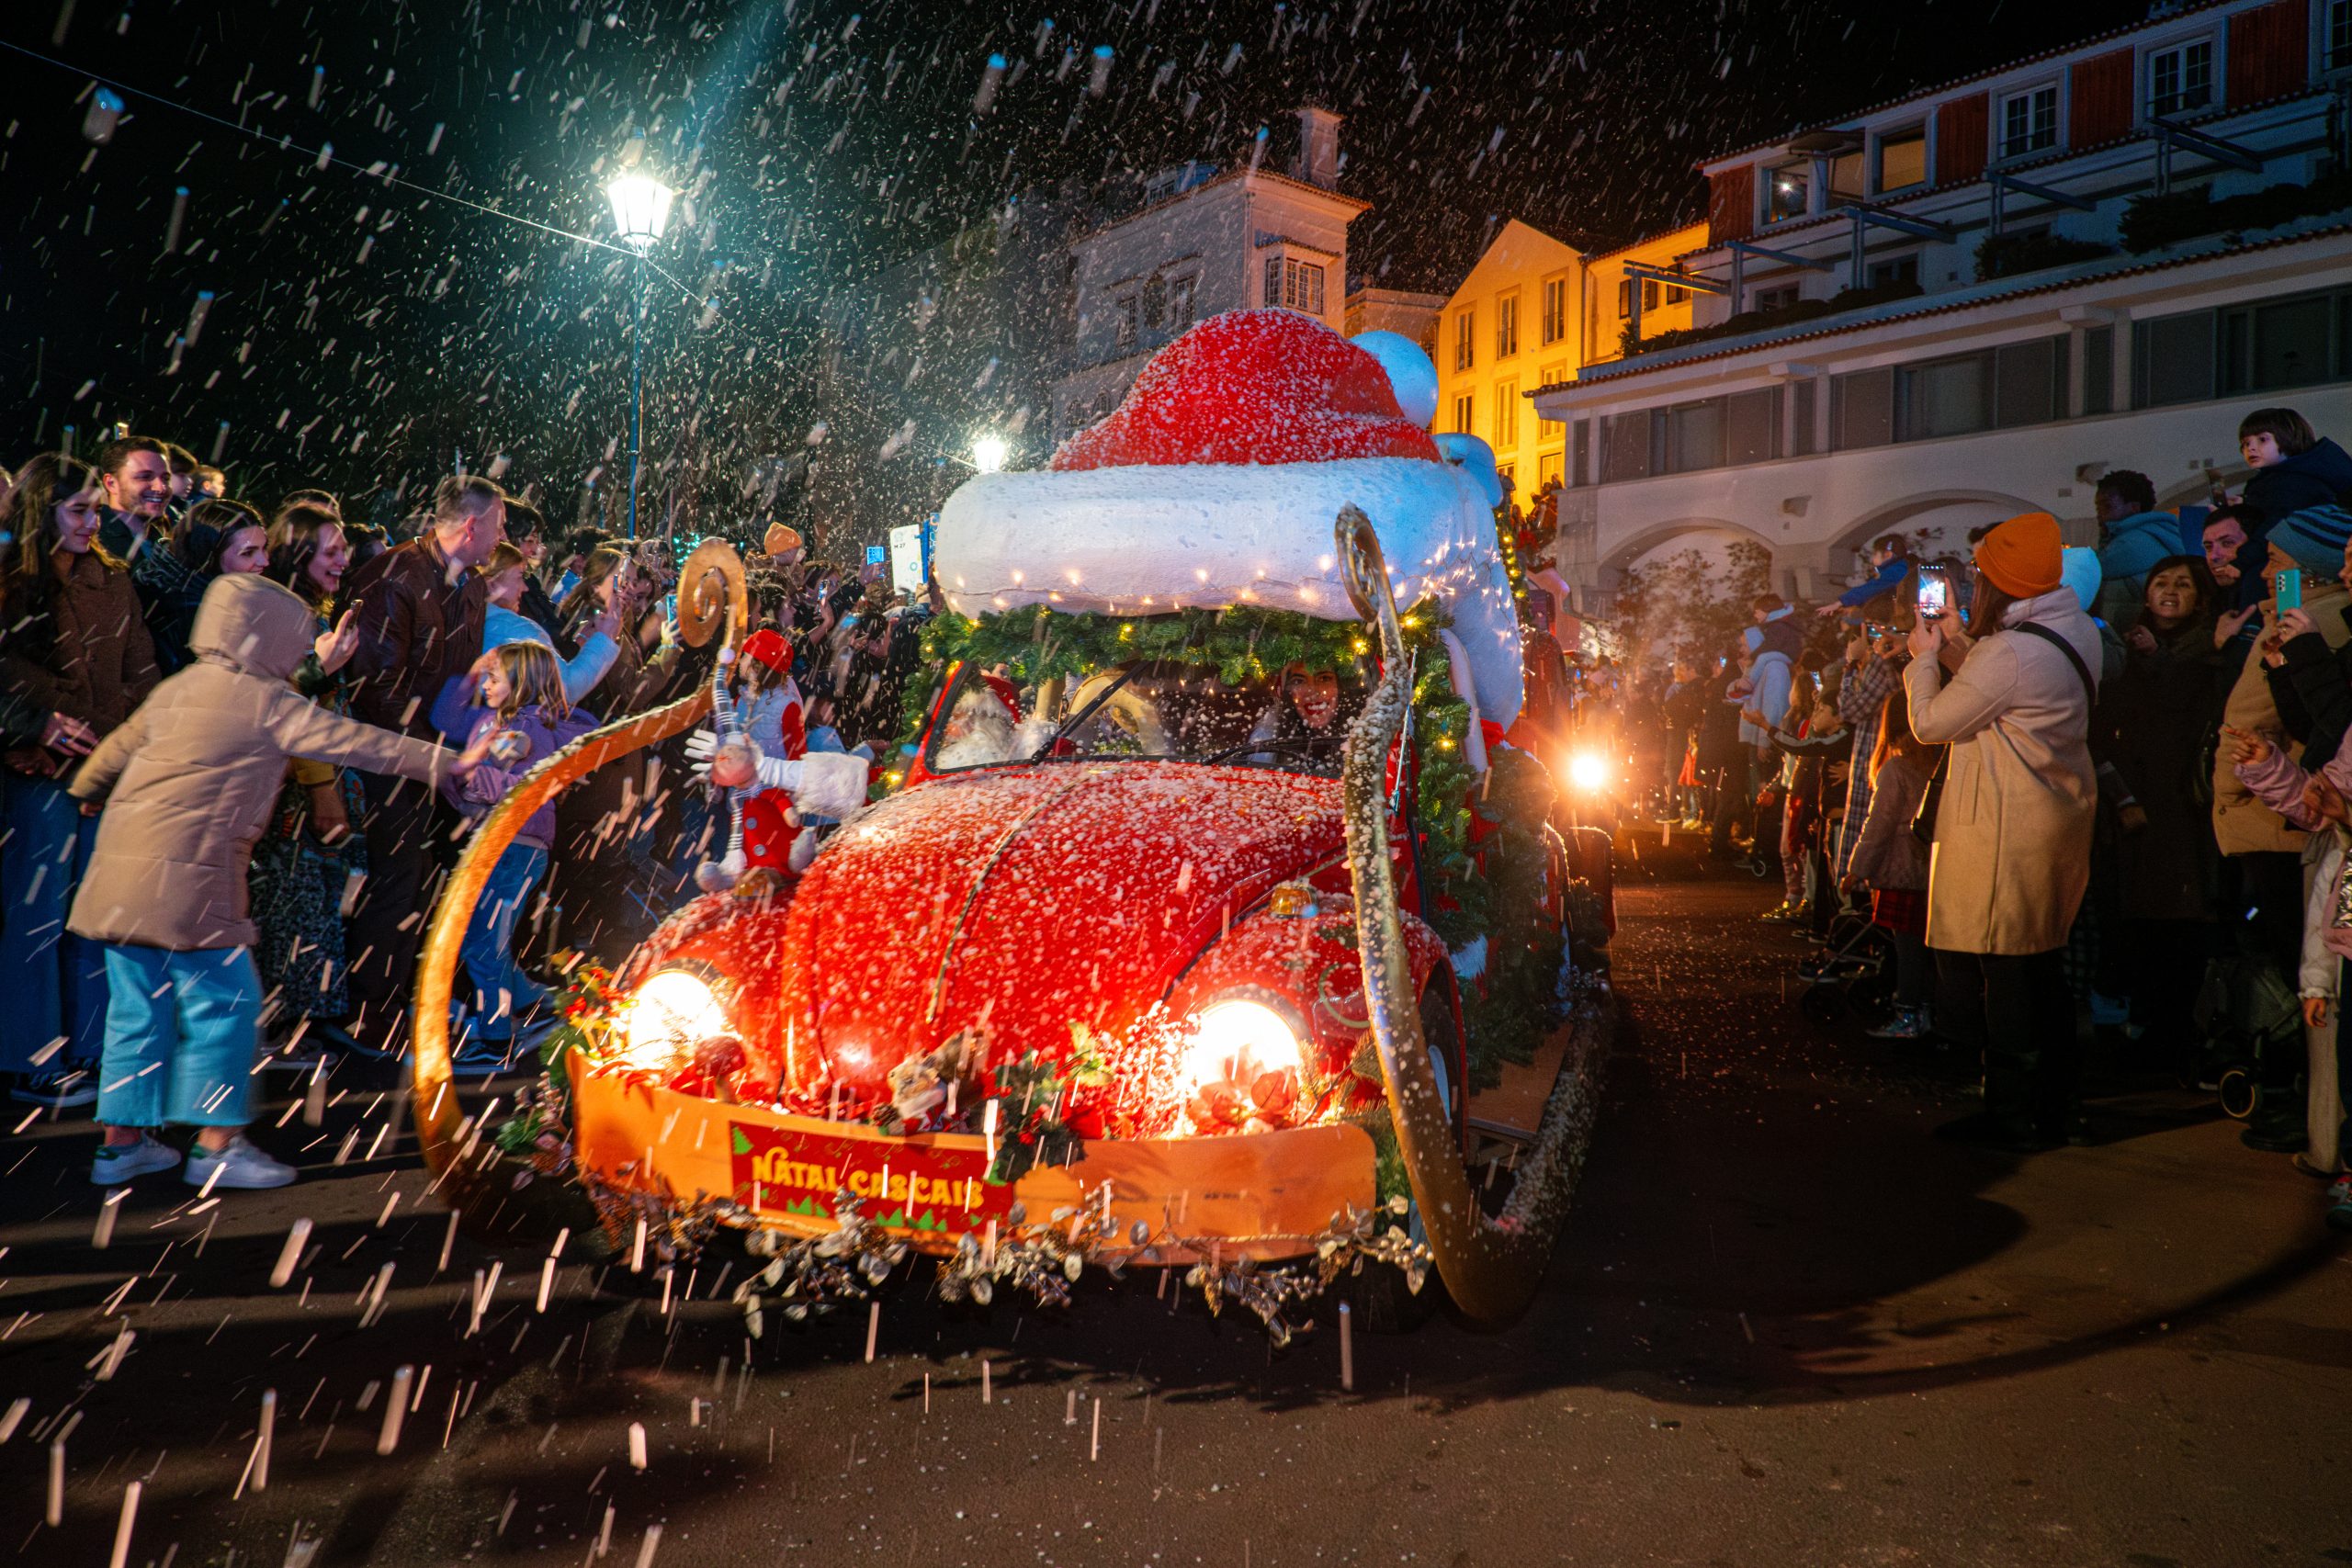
66,573 -> 457,952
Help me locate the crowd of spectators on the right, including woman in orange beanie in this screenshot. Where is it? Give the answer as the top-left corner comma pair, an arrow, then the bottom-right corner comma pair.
1618,409 -> 2352,1227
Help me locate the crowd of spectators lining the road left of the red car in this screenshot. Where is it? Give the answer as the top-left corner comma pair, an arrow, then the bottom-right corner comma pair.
0,433 -> 927,1187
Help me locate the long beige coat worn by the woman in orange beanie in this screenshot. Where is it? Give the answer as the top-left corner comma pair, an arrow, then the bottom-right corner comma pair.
1903,588 -> 2100,954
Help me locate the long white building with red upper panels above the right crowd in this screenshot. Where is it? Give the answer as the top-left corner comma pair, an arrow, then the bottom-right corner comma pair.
1532,0 -> 2352,614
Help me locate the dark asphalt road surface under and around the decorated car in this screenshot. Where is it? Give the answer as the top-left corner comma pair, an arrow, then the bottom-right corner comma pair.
0,841 -> 2352,1568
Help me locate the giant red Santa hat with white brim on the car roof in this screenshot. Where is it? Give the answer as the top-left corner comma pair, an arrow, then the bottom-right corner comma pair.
936,310 -> 1520,724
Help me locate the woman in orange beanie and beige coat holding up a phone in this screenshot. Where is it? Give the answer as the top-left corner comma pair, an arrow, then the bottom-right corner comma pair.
1903,513 -> 2100,1152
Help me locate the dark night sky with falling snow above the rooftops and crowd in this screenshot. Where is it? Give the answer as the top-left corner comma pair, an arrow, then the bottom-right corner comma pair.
0,0 -> 2145,540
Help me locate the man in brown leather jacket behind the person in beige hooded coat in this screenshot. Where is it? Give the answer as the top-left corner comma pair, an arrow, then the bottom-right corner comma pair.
344,475 -> 505,1051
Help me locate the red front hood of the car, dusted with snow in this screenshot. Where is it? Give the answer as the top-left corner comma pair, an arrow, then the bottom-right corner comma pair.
630,761 -> 1343,1112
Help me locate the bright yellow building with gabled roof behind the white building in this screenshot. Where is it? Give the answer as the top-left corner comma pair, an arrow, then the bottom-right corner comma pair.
1435,219 -> 1708,505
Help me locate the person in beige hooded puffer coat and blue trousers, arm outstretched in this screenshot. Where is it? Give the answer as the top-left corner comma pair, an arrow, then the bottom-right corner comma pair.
68,576 -> 480,1187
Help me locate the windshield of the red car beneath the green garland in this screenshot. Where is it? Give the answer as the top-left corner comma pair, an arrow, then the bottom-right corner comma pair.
924,663 -> 1364,778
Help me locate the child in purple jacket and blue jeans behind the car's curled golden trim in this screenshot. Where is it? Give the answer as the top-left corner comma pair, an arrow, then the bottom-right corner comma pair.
442,642 -> 595,1075
